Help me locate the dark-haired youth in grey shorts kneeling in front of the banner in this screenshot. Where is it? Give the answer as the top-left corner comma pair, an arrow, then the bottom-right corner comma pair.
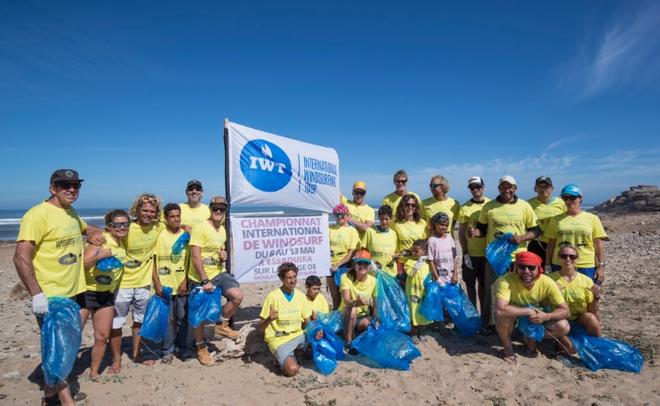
258,262 -> 323,377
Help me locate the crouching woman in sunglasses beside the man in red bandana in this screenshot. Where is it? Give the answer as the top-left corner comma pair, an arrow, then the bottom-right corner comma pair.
548,244 -> 603,354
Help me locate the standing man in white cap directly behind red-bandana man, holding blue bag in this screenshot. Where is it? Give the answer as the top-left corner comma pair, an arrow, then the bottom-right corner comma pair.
470,176 -> 541,335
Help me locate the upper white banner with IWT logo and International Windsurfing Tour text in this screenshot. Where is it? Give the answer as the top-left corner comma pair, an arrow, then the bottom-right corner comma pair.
227,122 -> 339,212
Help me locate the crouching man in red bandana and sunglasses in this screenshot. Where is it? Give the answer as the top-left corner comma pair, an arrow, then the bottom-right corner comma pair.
495,251 -> 570,364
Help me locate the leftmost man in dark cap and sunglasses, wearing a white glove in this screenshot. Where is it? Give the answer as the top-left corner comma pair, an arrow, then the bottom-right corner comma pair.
14,169 -> 104,405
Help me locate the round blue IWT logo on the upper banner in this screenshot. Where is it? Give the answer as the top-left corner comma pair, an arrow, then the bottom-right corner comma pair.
241,140 -> 291,192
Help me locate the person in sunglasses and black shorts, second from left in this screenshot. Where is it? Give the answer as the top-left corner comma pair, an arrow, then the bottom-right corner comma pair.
76,210 -> 130,379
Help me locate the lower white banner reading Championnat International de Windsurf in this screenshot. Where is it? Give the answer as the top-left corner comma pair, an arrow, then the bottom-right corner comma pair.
231,213 -> 330,282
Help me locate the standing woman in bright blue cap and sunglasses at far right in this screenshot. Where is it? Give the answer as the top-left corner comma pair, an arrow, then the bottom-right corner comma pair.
546,183 -> 608,284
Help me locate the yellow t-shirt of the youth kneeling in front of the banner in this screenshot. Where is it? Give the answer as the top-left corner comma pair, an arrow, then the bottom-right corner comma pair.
259,288 -> 311,353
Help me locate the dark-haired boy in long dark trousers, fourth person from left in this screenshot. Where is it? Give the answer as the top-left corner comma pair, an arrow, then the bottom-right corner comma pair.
152,203 -> 190,364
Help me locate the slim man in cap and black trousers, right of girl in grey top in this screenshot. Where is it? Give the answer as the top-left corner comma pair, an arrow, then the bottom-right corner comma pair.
458,176 -> 490,327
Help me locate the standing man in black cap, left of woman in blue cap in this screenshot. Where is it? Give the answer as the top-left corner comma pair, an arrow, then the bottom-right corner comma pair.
527,176 -> 566,269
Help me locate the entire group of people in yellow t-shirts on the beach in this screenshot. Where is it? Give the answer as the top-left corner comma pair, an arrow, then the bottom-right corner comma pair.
14,169 -> 607,404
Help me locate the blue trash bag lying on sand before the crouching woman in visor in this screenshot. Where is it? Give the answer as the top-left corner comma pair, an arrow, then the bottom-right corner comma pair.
351,323 -> 422,371
